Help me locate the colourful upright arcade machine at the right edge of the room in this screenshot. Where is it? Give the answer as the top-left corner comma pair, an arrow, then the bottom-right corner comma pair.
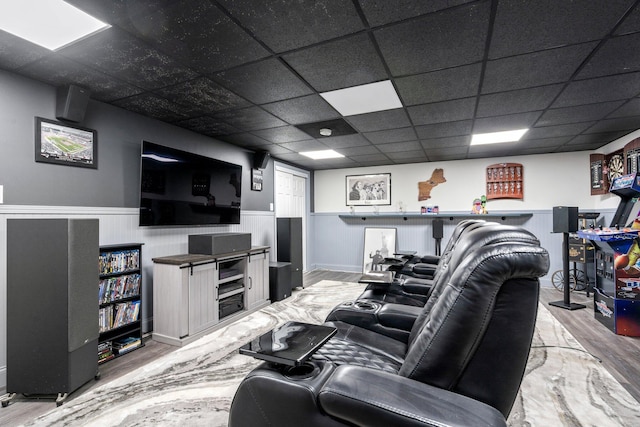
577,172 -> 640,337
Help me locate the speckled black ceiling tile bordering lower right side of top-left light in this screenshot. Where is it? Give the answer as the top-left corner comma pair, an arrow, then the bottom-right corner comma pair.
58,28 -> 196,89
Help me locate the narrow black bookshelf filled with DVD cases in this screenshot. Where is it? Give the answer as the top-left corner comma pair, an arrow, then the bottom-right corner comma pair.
98,243 -> 144,363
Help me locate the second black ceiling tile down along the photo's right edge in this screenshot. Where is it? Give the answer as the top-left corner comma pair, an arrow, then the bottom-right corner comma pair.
577,33 -> 640,79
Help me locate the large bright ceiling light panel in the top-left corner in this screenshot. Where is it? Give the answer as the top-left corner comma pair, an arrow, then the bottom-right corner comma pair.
0,0 -> 110,50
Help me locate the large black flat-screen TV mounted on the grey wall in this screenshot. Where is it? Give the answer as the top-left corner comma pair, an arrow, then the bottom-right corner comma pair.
140,141 -> 242,226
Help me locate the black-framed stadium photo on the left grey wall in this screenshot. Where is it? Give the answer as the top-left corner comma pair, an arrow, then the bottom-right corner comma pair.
35,117 -> 98,169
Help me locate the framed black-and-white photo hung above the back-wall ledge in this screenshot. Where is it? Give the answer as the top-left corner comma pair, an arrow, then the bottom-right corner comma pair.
346,173 -> 391,206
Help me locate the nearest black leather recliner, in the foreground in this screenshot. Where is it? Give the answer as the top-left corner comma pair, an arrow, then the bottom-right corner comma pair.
229,243 -> 549,427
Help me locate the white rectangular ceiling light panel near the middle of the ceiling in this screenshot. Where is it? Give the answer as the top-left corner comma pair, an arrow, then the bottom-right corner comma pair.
320,80 -> 402,116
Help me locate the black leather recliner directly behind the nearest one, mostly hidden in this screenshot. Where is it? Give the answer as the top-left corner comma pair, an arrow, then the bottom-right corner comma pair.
358,221 -> 540,307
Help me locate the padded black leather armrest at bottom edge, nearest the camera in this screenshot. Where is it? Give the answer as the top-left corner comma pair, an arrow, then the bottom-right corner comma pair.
318,365 -> 507,427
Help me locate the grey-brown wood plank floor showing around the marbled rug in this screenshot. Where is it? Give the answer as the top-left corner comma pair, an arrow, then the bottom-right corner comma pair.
0,270 -> 640,427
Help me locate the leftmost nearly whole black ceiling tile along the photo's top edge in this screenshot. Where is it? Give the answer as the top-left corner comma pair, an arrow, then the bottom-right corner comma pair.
117,0 -> 270,74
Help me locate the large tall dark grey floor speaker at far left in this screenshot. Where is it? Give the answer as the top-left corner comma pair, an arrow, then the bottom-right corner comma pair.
7,219 -> 99,404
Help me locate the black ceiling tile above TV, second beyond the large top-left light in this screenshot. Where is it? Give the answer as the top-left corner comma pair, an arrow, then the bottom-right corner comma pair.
156,77 -> 251,113
